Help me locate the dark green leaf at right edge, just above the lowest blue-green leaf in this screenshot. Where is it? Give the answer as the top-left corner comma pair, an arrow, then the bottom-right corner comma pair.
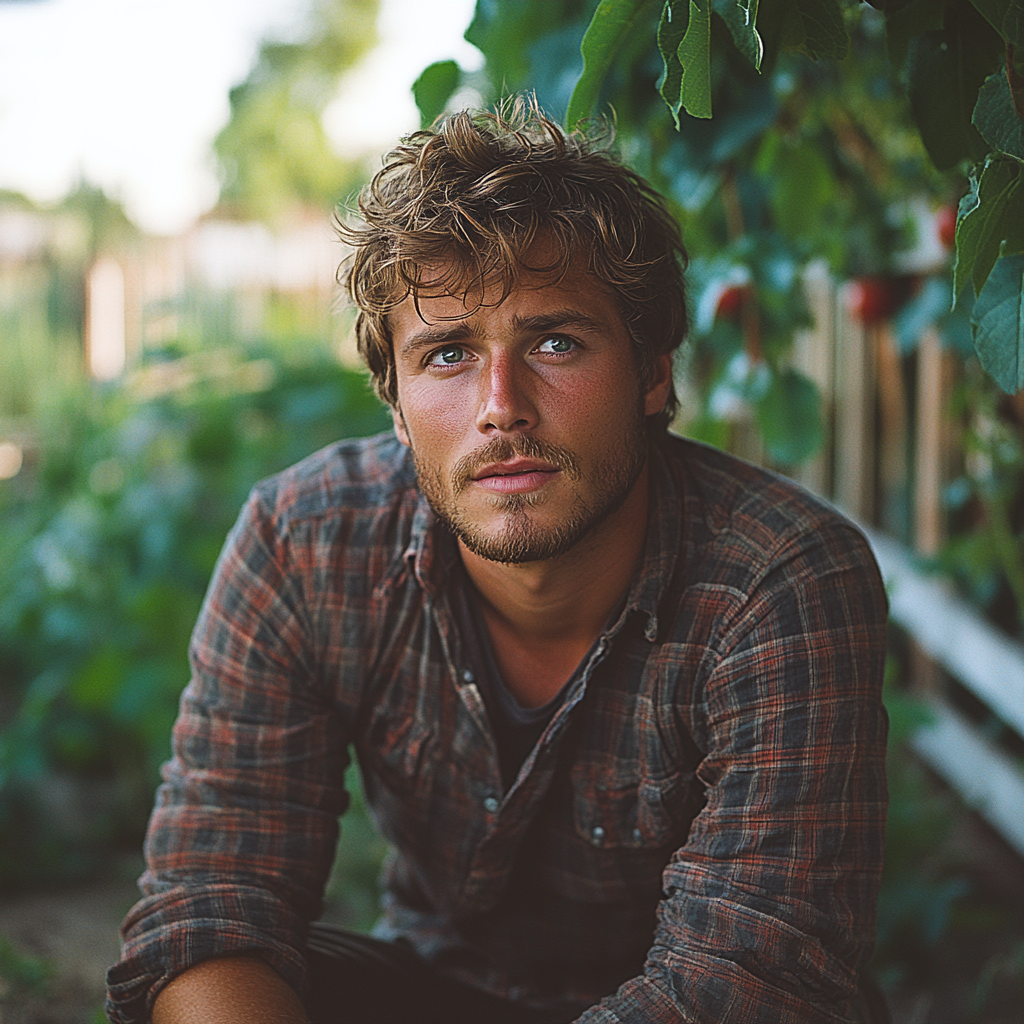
953,160 -> 1021,296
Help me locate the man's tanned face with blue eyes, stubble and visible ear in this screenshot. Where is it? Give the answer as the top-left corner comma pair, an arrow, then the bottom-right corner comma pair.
389,256 -> 671,563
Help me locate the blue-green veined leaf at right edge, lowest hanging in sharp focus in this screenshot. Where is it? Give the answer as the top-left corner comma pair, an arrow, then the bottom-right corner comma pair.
971,255 -> 1024,394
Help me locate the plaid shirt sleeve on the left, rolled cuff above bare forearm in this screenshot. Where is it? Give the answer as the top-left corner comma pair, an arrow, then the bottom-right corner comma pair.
108,493 -> 348,1024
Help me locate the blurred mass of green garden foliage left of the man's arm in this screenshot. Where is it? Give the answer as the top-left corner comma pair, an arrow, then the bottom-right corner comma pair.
0,346 -> 386,884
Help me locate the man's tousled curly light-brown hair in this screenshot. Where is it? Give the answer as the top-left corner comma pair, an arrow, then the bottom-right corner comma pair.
338,98 -> 687,430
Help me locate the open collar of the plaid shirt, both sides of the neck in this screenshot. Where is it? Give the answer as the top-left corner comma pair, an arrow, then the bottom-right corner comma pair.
403,443 -> 683,641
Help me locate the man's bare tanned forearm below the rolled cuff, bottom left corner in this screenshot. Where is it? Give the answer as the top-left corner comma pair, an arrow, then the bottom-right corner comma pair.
153,956 -> 308,1024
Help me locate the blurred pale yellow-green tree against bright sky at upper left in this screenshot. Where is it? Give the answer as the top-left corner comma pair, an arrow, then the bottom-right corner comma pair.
214,0 -> 378,220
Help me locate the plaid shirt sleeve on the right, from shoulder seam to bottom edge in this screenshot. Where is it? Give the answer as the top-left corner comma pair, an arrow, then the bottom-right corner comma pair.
578,526 -> 888,1024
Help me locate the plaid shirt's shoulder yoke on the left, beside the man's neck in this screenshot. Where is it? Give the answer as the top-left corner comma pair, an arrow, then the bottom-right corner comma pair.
254,431 -> 419,523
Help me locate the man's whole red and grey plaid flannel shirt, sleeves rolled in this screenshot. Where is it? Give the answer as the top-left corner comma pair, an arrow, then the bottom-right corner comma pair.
108,435 -> 886,1024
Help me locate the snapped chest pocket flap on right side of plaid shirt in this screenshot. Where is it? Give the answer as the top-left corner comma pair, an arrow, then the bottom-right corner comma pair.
572,766 -> 703,851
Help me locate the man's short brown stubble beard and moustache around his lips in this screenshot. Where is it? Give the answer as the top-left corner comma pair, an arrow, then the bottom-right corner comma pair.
413,411 -> 647,565
